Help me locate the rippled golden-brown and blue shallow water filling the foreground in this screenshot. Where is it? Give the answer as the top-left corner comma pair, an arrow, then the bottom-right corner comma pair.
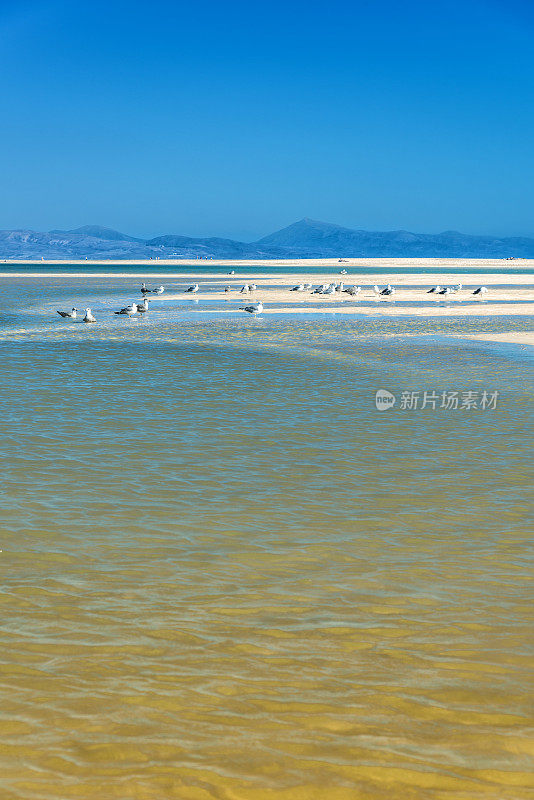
0,279 -> 534,800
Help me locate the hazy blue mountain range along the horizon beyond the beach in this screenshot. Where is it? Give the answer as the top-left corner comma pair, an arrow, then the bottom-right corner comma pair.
0,218 -> 534,260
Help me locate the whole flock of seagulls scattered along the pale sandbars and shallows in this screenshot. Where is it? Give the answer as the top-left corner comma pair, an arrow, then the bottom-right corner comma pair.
57,278 -> 494,322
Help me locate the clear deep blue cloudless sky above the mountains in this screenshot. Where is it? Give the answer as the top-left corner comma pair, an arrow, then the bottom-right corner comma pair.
0,0 -> 534,240
